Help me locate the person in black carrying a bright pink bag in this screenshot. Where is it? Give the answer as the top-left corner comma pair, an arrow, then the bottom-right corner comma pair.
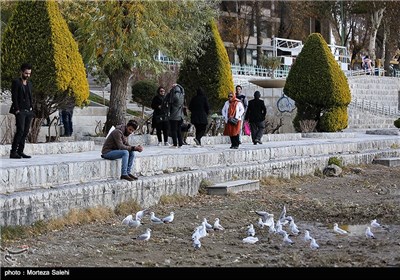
245,90 -> 267,145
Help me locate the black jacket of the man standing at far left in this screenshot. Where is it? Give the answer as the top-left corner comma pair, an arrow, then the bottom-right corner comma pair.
10,78 -> 33,114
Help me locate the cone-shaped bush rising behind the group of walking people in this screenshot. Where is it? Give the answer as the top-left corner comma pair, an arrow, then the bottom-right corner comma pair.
178,20 -> 234,112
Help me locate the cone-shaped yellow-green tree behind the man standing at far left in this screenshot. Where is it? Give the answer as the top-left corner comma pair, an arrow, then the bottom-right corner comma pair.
1,0 -> 89,142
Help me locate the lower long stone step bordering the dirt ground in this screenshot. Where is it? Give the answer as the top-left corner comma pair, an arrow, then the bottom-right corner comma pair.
0,149 -> 400,226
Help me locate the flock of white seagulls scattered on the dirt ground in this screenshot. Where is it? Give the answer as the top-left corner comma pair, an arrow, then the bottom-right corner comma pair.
122,203 -> 383,250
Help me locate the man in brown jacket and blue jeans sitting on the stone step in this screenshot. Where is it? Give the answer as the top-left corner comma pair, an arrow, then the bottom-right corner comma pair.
101,120 -> 143,181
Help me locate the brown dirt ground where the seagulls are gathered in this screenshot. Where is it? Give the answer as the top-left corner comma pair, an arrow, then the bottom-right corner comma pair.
2,165 -> 400,267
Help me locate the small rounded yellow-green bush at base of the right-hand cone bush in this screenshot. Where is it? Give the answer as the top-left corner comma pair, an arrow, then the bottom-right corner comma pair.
319,106 -> 348,132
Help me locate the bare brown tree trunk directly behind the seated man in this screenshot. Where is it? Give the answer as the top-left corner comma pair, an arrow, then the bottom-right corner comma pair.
103,69 -> 132,135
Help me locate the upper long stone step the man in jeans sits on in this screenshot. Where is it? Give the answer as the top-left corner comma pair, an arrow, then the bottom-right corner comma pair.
0,134 -> 400,194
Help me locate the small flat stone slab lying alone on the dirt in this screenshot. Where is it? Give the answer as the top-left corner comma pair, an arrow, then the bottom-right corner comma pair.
207,180 -> 260,195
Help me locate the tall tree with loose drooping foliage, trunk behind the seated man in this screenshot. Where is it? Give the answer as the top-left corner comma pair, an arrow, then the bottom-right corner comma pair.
64,0 -> 217,131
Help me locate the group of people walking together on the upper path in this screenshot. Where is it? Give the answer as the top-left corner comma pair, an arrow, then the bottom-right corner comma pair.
151,84 -> 267,152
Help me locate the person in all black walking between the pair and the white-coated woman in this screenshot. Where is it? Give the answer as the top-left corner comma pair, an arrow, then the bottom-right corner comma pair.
189,87 -> 210,146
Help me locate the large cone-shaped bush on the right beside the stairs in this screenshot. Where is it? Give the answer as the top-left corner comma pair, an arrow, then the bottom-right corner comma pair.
284,33 -> 351,131
